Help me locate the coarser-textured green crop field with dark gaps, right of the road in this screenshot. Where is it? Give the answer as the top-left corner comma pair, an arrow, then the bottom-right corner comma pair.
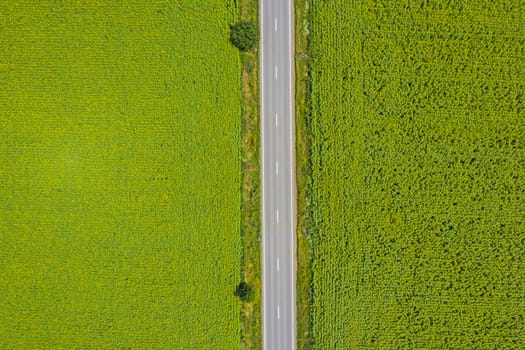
308,0 -> 525,349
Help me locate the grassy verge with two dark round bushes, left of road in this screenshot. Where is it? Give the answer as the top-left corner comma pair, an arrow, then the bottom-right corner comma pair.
241,0 -> 262,349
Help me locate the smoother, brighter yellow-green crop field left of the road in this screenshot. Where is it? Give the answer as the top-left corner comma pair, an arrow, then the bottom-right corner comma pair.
0,0 -> 241,349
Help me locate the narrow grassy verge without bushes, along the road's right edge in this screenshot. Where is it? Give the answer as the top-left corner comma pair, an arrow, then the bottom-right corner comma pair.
295,0 -> 312,349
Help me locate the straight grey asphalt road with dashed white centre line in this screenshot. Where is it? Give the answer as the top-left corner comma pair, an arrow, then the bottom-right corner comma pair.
260,0 -> 296,350
